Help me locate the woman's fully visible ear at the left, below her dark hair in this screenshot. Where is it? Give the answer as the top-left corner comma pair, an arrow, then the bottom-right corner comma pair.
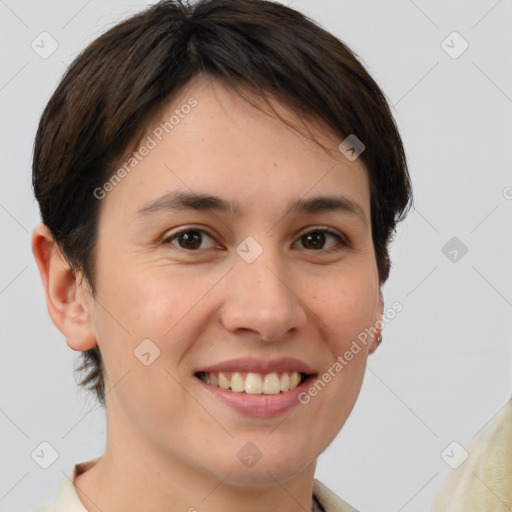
32,224 -> 97,351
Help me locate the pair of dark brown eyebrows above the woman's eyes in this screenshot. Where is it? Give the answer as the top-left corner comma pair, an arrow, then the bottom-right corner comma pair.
137,192 -> 368,224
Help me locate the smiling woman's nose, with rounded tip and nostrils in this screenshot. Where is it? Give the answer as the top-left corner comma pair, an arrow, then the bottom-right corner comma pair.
221,241 -> 307,342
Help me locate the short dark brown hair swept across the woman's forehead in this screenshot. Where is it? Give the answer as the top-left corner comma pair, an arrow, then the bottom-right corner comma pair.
32,0 -> 412,406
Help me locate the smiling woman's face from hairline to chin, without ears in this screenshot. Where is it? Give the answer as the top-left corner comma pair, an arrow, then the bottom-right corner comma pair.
79,76 -> 382,485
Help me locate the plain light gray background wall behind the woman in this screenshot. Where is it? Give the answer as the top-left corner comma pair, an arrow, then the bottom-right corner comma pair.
0,0 -> 512,512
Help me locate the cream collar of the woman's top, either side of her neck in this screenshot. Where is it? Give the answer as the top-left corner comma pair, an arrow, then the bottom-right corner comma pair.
34,457 -> 357,512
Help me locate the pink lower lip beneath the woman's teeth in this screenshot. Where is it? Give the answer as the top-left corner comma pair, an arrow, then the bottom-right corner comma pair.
196,377 -> 313,418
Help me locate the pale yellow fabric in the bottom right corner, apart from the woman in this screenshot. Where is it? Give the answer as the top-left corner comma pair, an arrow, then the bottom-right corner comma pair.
432,399 -> 512,512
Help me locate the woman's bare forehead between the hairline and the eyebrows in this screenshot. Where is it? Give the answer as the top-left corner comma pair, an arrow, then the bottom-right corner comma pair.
98,75 -> 369,224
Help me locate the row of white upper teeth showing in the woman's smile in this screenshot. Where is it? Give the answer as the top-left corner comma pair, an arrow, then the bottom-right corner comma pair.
199,372 -> 301,395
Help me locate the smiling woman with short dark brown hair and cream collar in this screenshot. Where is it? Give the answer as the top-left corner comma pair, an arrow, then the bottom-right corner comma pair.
32,0 -> 412,512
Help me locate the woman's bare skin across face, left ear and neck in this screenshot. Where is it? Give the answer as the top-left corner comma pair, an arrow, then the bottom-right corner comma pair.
32,75 -> 383,512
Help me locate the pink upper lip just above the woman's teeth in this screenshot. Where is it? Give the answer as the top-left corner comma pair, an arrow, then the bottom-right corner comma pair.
194,357 -> 316,375
